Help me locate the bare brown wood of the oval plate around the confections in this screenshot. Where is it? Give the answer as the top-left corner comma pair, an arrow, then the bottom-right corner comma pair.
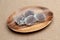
7,6 -> 53,33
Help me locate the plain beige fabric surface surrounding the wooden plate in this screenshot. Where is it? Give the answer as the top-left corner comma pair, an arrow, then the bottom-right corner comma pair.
0,0 -> 60,40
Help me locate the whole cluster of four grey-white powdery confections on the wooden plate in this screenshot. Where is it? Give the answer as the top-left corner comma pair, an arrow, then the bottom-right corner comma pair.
14,10 -> 46,25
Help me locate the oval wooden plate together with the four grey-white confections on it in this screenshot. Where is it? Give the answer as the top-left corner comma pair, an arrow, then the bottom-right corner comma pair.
7,6 -> 53,33
